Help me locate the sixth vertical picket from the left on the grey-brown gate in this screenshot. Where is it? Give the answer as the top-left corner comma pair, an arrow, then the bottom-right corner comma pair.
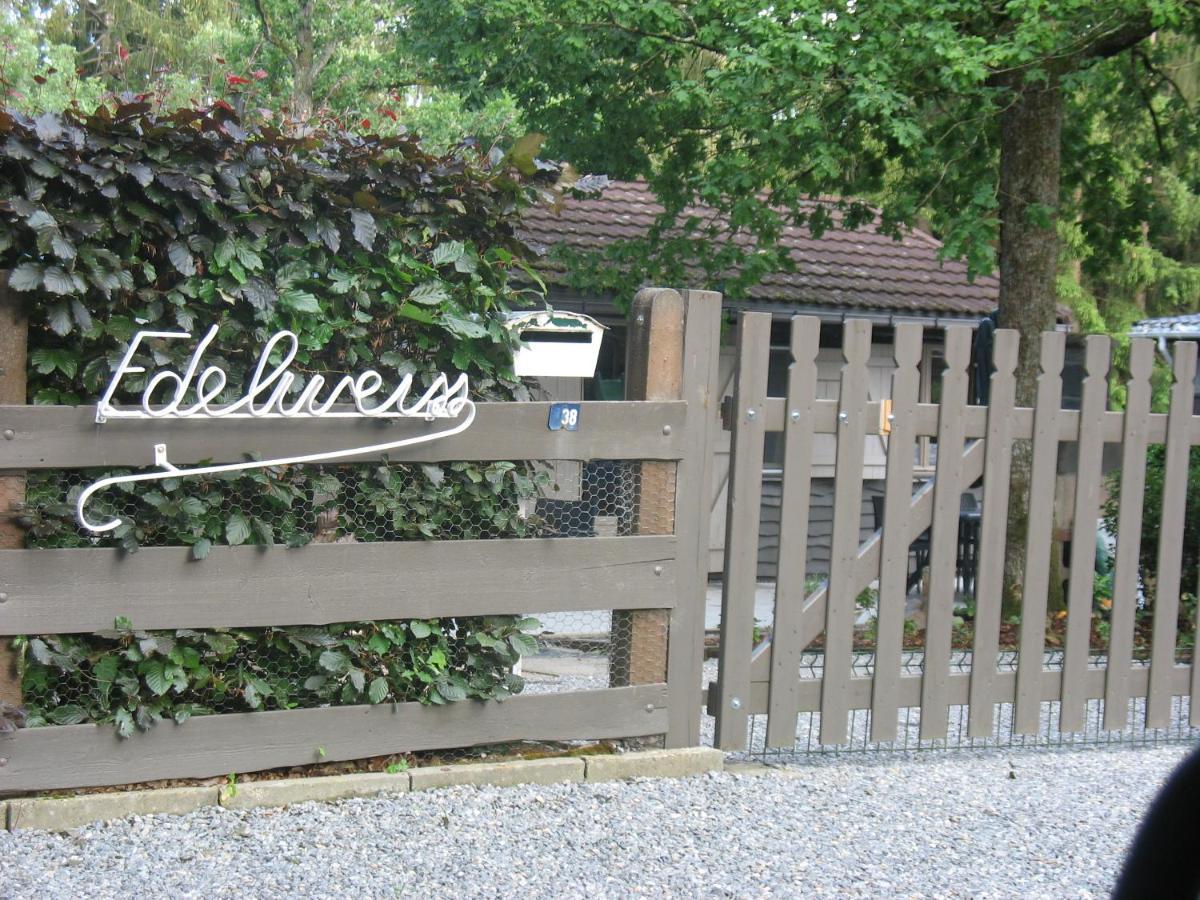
967,329 -> 1019,738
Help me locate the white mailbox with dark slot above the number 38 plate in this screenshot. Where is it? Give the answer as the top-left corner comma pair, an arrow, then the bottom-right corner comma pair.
506,310 -> 605,378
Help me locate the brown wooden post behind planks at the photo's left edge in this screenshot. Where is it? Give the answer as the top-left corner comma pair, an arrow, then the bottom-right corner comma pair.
0,272 -> 29,706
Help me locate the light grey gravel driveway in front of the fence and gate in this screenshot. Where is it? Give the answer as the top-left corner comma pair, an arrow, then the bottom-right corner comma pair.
0,745 -> 1187,900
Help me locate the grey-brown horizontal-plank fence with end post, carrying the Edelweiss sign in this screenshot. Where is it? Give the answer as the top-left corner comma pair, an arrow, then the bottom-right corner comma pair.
0,290 -> 720,793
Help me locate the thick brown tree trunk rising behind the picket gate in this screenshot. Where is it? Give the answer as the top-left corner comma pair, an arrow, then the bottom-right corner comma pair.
1000,76 -> 1063,616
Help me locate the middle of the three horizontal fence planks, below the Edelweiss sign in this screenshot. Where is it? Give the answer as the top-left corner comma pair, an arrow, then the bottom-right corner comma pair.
0,536 -> 678,635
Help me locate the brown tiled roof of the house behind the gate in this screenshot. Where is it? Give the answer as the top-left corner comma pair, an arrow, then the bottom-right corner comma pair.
522,181 -> 1000,316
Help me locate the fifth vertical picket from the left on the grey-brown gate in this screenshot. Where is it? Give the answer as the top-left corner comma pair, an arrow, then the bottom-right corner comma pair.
920,325 -> 971,740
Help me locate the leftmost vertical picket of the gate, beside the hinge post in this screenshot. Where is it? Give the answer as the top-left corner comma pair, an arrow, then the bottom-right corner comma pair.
715,312 -> 770,750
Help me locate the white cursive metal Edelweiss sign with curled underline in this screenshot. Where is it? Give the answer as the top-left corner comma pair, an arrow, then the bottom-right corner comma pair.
76,325 -> 475,534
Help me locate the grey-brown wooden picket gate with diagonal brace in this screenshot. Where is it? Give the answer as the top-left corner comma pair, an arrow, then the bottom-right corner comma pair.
707,313 -> 1200,750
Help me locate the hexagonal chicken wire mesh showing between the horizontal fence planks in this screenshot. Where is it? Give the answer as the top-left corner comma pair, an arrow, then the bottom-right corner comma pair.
16,460 -> 676,758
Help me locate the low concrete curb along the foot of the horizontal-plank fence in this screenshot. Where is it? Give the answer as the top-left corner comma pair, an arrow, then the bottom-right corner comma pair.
0,748 -> 725,832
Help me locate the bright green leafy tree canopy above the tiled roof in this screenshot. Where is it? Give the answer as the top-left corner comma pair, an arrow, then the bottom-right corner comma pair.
403,0 -> 1200,352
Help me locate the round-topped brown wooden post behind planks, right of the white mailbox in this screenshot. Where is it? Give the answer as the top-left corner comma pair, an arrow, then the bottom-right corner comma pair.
608,288 -> 684,686
